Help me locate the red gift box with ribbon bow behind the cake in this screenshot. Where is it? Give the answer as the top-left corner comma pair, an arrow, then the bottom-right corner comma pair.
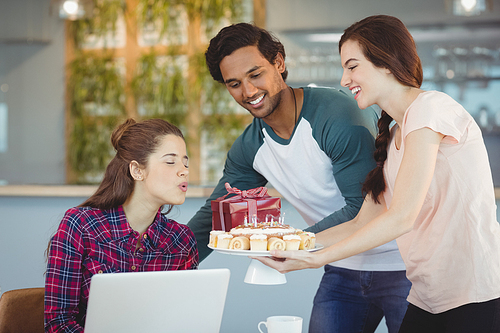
211,183 -> 281,231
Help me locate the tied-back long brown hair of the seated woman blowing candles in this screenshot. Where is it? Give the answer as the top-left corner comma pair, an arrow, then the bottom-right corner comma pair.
80,118 -> 184,210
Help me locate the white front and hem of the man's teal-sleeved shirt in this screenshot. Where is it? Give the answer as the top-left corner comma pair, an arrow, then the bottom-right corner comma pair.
254,119 -> 405,271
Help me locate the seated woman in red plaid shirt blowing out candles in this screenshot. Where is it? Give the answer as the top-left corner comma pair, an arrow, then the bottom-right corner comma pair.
45,119 -> 199,332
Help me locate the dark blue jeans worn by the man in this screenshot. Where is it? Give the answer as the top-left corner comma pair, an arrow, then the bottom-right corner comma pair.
309,265 -> 411,333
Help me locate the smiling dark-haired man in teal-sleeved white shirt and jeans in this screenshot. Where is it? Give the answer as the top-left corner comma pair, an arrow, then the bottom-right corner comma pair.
188,23 -> 410,332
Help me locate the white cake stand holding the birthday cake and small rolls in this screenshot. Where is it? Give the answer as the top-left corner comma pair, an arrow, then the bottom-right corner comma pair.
208,244 -> 323,285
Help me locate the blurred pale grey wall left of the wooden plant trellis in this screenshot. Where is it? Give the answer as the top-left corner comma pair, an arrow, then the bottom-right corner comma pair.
0,0 -> 65,184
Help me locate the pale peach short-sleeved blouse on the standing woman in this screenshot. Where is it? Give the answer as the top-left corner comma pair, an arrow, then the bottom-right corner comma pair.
384,91 -> 500,313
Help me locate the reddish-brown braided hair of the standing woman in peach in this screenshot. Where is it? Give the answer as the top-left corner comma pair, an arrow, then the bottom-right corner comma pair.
339,15 -> 423,203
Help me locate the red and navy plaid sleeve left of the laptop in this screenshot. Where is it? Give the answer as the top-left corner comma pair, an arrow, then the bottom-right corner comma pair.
45,210 -> 83,332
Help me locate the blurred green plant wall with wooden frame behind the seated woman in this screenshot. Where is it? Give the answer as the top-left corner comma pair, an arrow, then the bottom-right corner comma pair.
68,0 -> 249,183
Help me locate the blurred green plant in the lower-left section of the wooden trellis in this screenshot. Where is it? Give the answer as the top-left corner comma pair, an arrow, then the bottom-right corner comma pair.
68,53 -> 125,183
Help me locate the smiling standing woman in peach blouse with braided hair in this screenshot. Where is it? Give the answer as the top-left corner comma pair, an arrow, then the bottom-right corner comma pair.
256,15 -> 500,333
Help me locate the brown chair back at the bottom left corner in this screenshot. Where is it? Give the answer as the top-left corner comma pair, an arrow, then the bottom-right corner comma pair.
0,288 -> 45,333
